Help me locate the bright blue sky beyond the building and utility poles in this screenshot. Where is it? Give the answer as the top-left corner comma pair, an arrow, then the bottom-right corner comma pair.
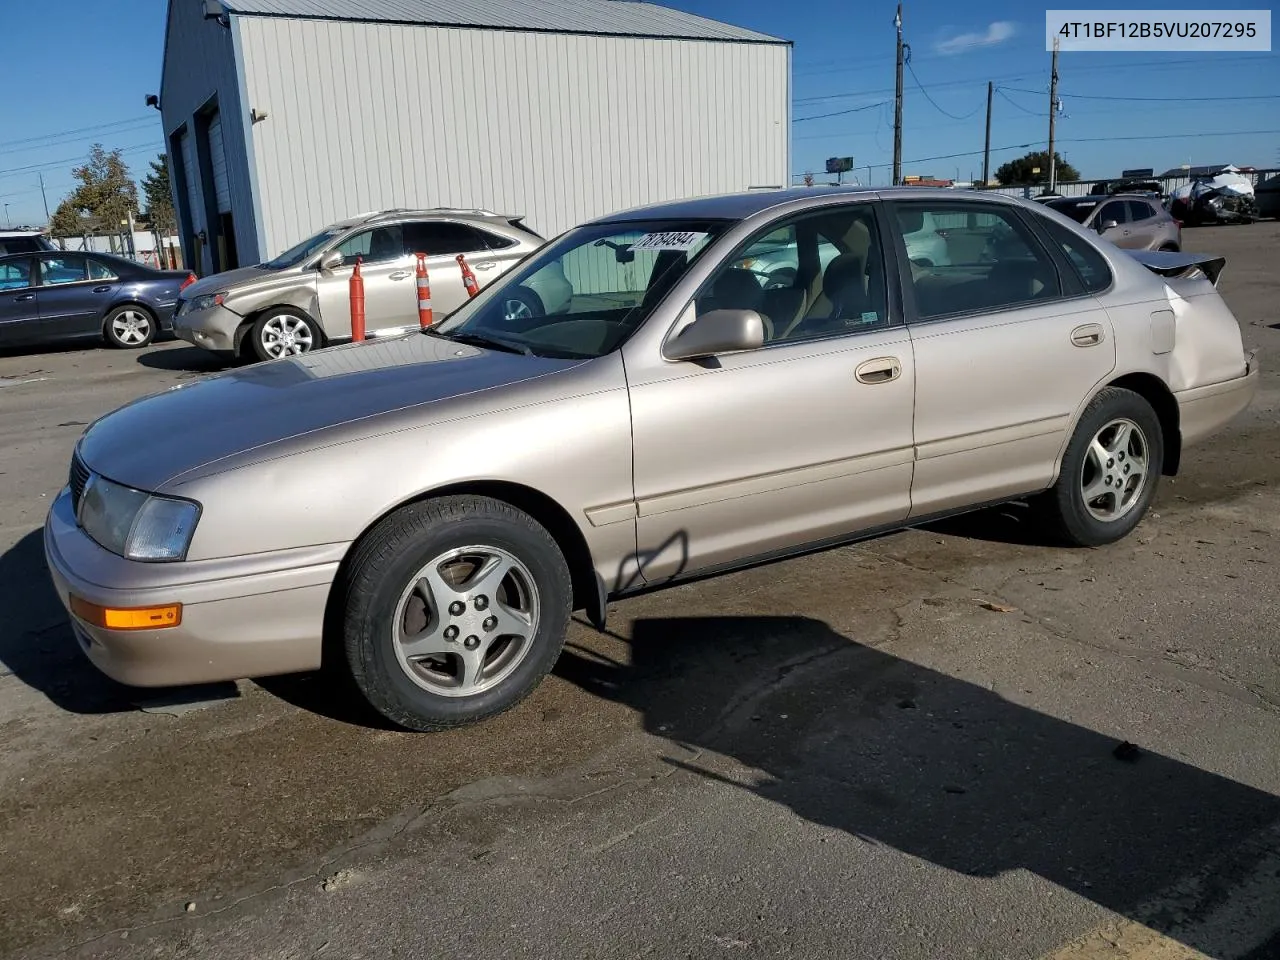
0,0 -> 1280,223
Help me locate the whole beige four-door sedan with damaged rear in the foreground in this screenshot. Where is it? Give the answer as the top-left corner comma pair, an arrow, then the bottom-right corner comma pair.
45,188 -> 1258,730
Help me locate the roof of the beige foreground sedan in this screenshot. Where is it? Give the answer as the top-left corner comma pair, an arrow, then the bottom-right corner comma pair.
589,187 -> 1023,224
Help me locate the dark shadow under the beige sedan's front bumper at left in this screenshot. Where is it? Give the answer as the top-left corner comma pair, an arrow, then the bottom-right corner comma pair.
0,530 -> 236,713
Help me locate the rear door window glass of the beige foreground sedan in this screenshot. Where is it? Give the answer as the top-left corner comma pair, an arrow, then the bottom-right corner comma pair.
895,201 -> 1062,320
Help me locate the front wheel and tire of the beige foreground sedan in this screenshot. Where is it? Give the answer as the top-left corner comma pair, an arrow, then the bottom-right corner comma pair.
342,495 -> 572,731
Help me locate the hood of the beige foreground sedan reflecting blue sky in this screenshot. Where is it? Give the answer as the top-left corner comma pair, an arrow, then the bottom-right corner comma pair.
77,333 -> 584,490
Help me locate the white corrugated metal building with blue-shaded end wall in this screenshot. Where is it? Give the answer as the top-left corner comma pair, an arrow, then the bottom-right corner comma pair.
160,0 -> 791,273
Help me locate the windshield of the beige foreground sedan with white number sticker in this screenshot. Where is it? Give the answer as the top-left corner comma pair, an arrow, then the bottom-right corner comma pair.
425,220 -> 733,358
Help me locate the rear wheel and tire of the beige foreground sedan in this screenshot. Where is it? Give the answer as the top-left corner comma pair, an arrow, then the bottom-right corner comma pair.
1041,387 -> 1165,547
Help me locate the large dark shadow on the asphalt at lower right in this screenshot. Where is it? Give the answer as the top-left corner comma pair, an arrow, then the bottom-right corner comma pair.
556,617 -> 1280,956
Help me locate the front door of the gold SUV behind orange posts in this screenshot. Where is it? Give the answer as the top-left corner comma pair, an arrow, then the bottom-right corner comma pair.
316,224 -> 417,340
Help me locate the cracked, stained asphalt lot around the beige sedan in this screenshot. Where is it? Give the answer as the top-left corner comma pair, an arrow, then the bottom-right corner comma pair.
0,223 -> 1280,960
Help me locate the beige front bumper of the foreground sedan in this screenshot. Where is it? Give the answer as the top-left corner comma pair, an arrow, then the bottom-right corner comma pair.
45,488 -> 338,686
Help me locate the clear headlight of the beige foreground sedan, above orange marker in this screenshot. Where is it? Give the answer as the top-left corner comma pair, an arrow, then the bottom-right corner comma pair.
77,474 -> 200,561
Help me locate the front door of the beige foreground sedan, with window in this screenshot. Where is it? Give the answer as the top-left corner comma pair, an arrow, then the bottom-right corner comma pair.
623,201 -> 915,582
